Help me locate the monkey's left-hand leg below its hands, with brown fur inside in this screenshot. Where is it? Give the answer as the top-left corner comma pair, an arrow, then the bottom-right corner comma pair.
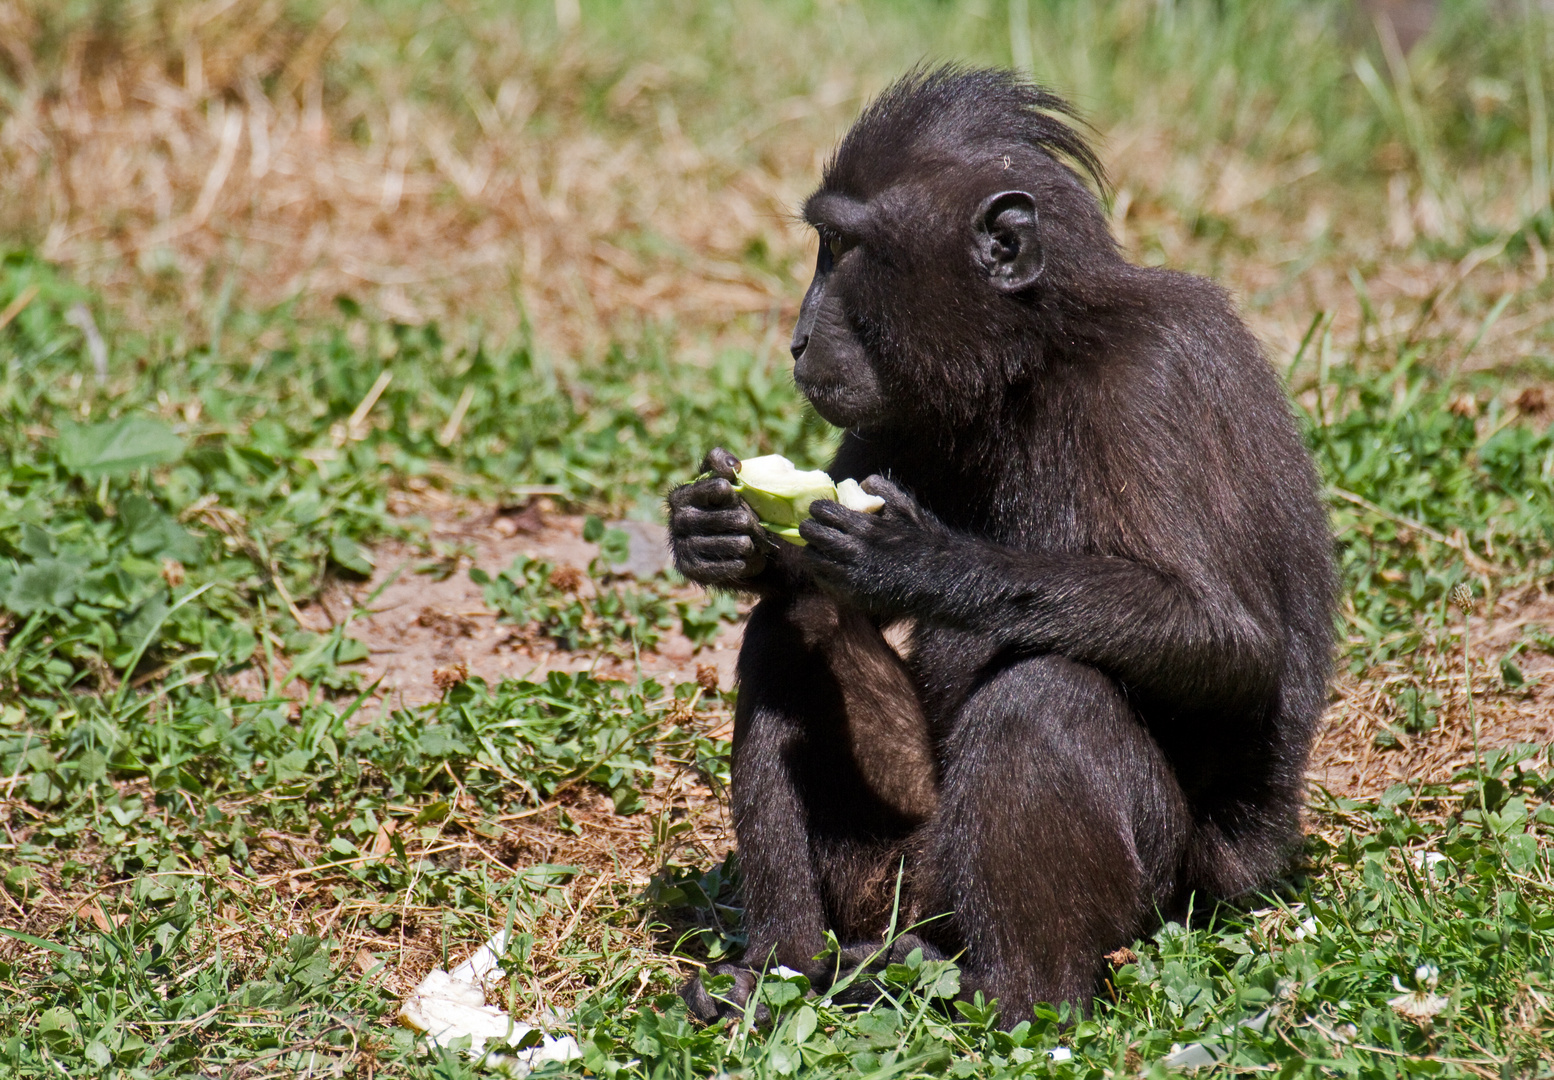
685,595 -> 936,1018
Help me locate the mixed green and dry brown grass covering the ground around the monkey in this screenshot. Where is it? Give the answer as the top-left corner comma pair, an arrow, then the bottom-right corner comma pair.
0,0 -> 1554,1077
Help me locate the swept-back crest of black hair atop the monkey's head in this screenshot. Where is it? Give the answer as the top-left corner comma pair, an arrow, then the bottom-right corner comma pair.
824,64 -> 1111,197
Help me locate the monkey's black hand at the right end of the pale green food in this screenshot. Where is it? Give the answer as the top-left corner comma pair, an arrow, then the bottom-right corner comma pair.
799,476 -> 953,615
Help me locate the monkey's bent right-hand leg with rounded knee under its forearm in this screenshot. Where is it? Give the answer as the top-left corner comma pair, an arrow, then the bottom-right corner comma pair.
918,656 -> 1190,1026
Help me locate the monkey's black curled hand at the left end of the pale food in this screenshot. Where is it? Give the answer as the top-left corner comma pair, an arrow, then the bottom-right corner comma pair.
668,446 -> 775,589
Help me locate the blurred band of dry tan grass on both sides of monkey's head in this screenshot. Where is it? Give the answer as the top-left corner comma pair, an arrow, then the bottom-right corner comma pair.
0,0 -> 1551,365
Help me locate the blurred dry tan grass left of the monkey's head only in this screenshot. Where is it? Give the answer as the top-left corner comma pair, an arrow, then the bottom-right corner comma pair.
0,0 -> 851,353
